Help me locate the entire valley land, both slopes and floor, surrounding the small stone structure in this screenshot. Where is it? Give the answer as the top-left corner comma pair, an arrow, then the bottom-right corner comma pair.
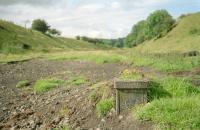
0,13 -> 200,130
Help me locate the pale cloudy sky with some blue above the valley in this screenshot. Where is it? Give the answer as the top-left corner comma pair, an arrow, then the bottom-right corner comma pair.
0,0 -> 200,38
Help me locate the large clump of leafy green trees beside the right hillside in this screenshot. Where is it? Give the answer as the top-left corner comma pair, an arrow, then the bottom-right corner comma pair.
125,10 -> 175,47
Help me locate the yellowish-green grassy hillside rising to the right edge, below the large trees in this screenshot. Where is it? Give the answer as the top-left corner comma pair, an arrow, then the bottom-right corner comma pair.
135,13 -> 200,53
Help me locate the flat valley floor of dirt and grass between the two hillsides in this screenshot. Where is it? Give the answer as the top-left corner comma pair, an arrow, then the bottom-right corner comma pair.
1,49 -> 200,129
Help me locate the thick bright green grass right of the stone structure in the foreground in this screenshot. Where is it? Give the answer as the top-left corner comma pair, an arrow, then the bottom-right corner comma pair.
137,77 -> 200,130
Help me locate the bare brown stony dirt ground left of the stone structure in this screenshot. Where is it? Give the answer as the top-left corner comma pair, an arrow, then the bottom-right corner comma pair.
0,59 -> 152,130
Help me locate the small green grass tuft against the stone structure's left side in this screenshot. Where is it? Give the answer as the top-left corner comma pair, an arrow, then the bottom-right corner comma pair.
96,98 -> 114,116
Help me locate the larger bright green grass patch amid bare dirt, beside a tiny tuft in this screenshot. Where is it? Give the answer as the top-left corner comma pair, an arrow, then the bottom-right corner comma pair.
33,78 -> 65,93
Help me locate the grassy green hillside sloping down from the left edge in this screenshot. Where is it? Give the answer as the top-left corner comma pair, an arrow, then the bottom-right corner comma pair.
0,20 -> 105,54
